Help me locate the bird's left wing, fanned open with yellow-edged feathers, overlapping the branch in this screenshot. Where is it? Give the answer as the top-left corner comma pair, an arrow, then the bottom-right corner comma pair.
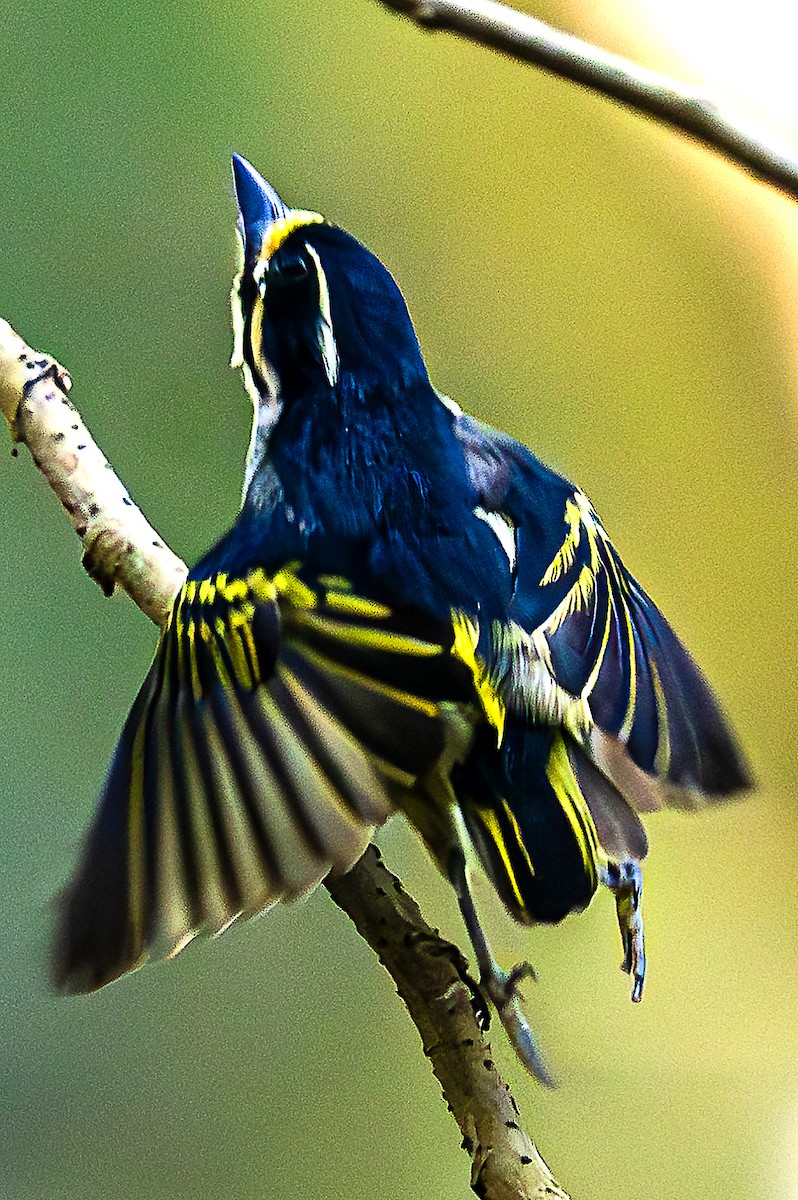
55,565 -> 473,991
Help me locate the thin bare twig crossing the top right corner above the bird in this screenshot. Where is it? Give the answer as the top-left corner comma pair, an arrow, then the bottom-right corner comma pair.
379,0 -> 798,199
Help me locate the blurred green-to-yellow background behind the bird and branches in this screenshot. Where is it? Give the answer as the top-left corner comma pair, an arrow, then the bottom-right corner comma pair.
0,0 -> 798,1200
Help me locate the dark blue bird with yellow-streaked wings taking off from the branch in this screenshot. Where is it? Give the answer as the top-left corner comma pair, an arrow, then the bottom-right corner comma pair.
53,155 -> 751,1076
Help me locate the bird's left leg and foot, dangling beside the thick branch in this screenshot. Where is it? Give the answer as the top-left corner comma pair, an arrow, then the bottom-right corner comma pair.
449,848 -> 554,1087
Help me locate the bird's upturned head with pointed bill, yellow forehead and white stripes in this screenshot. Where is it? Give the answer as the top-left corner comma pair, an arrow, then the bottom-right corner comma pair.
232,155 -> 426,416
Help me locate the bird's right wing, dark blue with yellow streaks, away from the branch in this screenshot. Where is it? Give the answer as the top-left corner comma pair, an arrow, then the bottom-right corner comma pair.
456,416 -> 749,827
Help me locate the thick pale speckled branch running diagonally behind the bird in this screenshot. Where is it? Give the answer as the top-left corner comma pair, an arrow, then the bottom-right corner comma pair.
0,319 -> 568,1200
